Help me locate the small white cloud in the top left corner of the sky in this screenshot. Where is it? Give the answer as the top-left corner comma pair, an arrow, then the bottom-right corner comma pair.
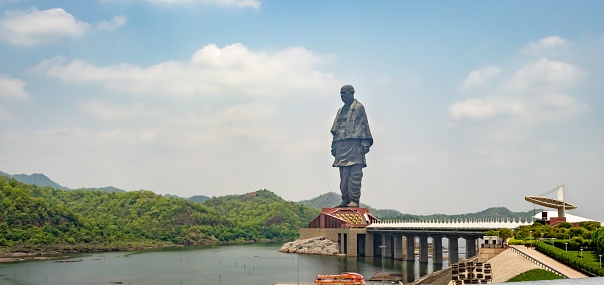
0,8 -> 89,45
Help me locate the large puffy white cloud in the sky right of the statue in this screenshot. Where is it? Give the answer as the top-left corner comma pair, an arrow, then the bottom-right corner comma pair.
449,58 -> 589,126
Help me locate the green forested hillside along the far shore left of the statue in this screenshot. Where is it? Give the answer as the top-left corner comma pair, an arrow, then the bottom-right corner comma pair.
0,176 -> 319,252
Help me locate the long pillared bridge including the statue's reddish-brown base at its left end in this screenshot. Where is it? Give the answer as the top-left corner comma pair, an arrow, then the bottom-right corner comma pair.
300,205 -> 532,264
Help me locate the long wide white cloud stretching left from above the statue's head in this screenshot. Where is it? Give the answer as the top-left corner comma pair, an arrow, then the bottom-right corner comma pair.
35,44 -> 335,96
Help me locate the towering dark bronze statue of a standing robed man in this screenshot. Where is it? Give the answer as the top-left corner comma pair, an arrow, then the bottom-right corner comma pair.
331,85 -> 373,208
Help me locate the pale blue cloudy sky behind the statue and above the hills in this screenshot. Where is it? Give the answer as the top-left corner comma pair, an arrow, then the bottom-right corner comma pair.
0,0 -> 604,221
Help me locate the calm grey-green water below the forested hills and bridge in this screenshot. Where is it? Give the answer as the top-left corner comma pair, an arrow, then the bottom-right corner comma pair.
0,244 -> 460,285
